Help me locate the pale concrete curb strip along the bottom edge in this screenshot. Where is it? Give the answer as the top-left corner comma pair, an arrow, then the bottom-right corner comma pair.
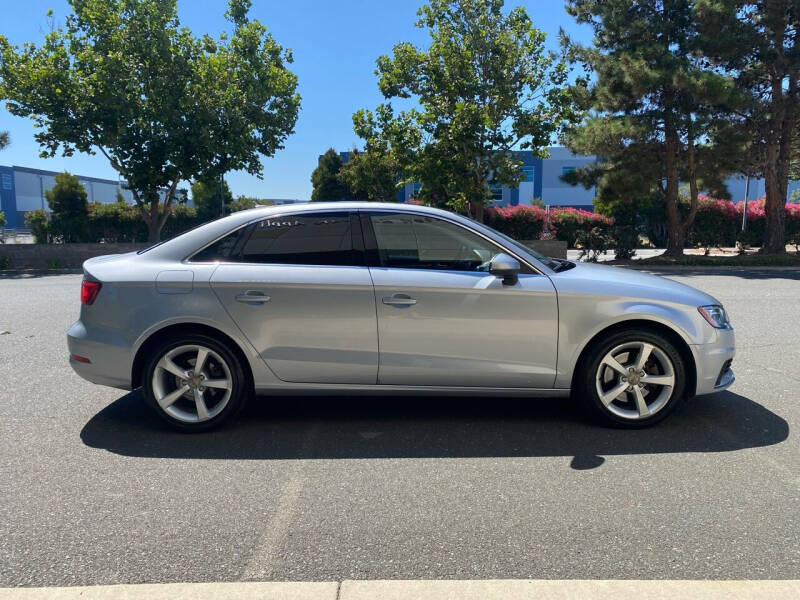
0,579 -> 800,600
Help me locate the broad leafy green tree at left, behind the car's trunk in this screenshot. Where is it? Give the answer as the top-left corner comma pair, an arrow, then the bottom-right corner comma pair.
0,0 -> 300,241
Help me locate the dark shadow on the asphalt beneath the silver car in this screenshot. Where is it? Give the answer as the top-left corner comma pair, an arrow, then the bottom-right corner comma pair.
81,392 -> 789,469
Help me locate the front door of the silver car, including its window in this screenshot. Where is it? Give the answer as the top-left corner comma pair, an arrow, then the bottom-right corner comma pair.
362,211 -> 558,388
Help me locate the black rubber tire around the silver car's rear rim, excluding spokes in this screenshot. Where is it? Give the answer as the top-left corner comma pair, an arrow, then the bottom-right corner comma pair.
142,334 -> 252,432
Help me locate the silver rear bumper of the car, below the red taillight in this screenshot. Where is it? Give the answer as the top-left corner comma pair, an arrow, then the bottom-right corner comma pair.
67,321 -> 132,390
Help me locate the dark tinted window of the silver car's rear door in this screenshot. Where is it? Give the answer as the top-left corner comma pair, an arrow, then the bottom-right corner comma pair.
236,212 -> 356,265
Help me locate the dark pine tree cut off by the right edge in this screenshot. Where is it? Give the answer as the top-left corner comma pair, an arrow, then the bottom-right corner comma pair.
697,0 -> 800,253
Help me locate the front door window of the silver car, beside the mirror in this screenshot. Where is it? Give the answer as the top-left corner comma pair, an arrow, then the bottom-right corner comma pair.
370,213 -> 502,271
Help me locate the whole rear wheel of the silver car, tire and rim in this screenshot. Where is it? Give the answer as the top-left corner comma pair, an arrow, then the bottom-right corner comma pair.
143,335 -> 248,431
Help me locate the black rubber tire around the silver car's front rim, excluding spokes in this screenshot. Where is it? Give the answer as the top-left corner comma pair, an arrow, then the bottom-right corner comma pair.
573,329 -> 686,429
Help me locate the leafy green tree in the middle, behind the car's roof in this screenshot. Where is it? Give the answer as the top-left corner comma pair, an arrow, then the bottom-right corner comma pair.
356,0 -> 576,219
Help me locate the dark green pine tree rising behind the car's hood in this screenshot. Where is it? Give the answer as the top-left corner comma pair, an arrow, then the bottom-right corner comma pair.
563,0 -> 737,256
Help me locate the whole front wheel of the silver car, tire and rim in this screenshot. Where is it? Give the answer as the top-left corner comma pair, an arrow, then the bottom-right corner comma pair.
577,330 -> 686,428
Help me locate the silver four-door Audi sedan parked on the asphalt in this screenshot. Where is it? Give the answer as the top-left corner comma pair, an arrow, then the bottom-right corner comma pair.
67,203 -> 735,431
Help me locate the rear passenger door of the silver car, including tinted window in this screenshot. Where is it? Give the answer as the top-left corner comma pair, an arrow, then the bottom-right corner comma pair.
208,211 -> 378,384
